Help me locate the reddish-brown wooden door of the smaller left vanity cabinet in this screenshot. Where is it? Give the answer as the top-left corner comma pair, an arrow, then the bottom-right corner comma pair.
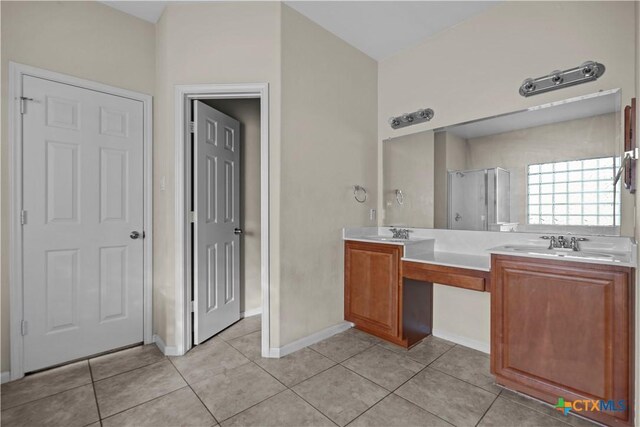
344,242 -> 402,337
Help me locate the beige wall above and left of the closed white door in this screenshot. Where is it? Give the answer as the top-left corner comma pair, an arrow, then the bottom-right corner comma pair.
0,1 -> 155,372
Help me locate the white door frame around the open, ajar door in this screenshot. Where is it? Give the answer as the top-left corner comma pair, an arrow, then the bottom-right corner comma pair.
172,83 -> 277,357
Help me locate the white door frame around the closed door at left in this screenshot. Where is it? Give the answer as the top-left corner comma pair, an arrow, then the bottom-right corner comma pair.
8,62 -> 153,380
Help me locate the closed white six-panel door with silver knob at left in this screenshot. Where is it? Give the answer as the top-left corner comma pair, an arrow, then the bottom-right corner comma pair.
22,76 -> 143,372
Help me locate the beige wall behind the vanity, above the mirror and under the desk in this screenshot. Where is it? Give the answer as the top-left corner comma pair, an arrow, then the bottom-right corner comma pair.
378,2 -> 637,352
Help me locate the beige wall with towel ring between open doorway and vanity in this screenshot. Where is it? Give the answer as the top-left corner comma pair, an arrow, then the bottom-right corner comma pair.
276,7 -> 377,346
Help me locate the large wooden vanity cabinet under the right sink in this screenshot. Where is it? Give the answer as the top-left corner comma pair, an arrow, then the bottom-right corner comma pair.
491,255 -> 634,426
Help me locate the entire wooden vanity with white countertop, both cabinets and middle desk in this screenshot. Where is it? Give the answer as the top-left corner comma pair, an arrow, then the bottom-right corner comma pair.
343,228 -> 637,426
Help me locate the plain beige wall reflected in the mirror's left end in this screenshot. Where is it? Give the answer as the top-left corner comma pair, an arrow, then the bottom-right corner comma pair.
380,131 -> 435,228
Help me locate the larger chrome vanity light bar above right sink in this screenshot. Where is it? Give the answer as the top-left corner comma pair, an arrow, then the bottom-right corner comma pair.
520,61 -> 605,96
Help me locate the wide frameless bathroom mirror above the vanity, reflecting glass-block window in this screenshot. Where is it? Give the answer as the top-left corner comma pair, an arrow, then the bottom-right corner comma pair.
382,89 -> 635,236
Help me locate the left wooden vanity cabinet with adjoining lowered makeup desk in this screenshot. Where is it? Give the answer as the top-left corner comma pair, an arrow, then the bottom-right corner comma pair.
345,237 -> 491,348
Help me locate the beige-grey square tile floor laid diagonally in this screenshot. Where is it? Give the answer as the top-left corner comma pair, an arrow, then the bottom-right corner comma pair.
1,316 -> 593,427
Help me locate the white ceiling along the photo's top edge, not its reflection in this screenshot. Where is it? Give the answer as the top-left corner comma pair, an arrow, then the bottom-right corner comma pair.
101,1 -> 498,60
